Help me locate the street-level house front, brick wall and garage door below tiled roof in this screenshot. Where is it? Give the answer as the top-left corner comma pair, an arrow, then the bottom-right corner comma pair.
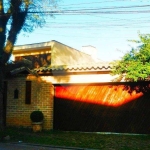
6,75 -> 150,133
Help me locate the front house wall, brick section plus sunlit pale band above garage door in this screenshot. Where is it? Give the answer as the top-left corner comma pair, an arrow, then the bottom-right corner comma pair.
6,75 -> 113,129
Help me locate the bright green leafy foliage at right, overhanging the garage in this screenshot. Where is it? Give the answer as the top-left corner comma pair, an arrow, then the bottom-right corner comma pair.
112,34 -> 150,81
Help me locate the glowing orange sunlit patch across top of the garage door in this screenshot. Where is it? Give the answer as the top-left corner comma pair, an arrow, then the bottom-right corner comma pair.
55,85 -> 143,107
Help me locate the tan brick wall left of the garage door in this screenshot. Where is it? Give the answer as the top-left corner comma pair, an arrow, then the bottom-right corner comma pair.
6,75 -> 54,129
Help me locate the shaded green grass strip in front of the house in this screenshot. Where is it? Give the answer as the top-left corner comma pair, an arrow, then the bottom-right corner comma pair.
0,128 -> 150,150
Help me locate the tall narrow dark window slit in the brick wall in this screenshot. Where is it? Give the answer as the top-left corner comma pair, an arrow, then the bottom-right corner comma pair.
25,81 -> 31,104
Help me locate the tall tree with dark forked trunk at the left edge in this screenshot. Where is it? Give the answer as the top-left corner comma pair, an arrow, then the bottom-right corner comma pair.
0,0 -> 58,128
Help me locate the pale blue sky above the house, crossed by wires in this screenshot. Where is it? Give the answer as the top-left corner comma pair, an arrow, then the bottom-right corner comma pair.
16,0 -> 150,61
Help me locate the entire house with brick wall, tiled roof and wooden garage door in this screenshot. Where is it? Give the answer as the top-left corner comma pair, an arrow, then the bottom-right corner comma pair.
5,41 -> 150,133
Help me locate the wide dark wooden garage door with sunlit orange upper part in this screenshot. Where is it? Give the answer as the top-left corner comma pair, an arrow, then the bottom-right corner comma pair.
54,84 -> 150,133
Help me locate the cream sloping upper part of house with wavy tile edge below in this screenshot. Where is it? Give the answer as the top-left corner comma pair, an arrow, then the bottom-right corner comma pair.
14,40 -> 111,73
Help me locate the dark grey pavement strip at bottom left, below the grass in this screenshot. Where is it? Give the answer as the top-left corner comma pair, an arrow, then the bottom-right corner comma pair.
0,143 -> 91,150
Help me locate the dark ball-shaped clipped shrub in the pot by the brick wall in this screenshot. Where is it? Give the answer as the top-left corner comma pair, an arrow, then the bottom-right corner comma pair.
30,110 -> 44,122
